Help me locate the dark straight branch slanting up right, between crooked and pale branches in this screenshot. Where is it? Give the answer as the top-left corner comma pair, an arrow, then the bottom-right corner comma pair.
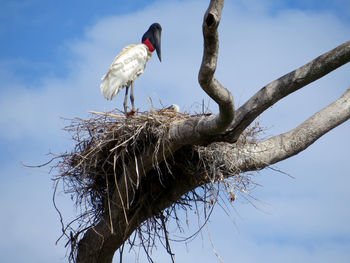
221,41 -> 350,142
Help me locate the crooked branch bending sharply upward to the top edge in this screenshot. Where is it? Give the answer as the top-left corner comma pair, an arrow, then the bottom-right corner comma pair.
169,0 -> 235,144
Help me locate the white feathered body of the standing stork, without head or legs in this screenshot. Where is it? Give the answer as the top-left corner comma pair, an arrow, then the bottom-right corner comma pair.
100,44 -> 152,100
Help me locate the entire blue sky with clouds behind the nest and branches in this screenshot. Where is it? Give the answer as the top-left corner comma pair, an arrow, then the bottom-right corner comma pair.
0,0 -> 350,263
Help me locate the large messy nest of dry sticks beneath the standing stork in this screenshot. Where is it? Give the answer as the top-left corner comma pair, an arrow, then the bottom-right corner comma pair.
54,110 -> 261,261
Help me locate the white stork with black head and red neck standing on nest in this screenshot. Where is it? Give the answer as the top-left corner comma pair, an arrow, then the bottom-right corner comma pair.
100,23 -> 162,114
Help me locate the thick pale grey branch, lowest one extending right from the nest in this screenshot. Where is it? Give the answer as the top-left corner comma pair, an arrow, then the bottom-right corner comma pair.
234,88 -> 350,171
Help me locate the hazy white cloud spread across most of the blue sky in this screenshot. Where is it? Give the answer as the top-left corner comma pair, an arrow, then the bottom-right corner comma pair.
0,1 -> 350,262
